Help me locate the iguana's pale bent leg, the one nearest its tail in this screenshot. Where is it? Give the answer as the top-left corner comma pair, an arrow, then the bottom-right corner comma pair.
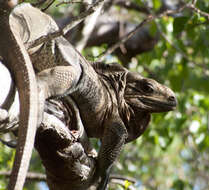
37,29 -> 82,107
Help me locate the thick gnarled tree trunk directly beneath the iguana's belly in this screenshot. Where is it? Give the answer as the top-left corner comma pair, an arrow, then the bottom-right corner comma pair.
2,98 -> 97,190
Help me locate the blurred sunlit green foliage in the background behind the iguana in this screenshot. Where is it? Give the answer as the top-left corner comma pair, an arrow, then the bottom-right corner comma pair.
0,0 -> 209,190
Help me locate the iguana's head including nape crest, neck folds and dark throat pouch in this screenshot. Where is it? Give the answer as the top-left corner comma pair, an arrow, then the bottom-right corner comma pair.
93,63 -> 177,143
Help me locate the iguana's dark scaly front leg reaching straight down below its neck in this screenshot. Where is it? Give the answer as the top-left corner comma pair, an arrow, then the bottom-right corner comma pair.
96,116 -> 128,190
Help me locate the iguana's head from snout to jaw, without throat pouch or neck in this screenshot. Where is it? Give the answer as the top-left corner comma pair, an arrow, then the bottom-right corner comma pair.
124,72 -> 177,113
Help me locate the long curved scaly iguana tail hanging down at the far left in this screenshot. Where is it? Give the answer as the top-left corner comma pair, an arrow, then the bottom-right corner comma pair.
0,0 -> 38,190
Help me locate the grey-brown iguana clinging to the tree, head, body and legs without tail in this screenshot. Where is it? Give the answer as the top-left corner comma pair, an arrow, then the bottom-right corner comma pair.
2,4 -> 177,190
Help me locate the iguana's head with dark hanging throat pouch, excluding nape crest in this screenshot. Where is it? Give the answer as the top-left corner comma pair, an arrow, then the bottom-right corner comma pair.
122,72 -> 177,143
